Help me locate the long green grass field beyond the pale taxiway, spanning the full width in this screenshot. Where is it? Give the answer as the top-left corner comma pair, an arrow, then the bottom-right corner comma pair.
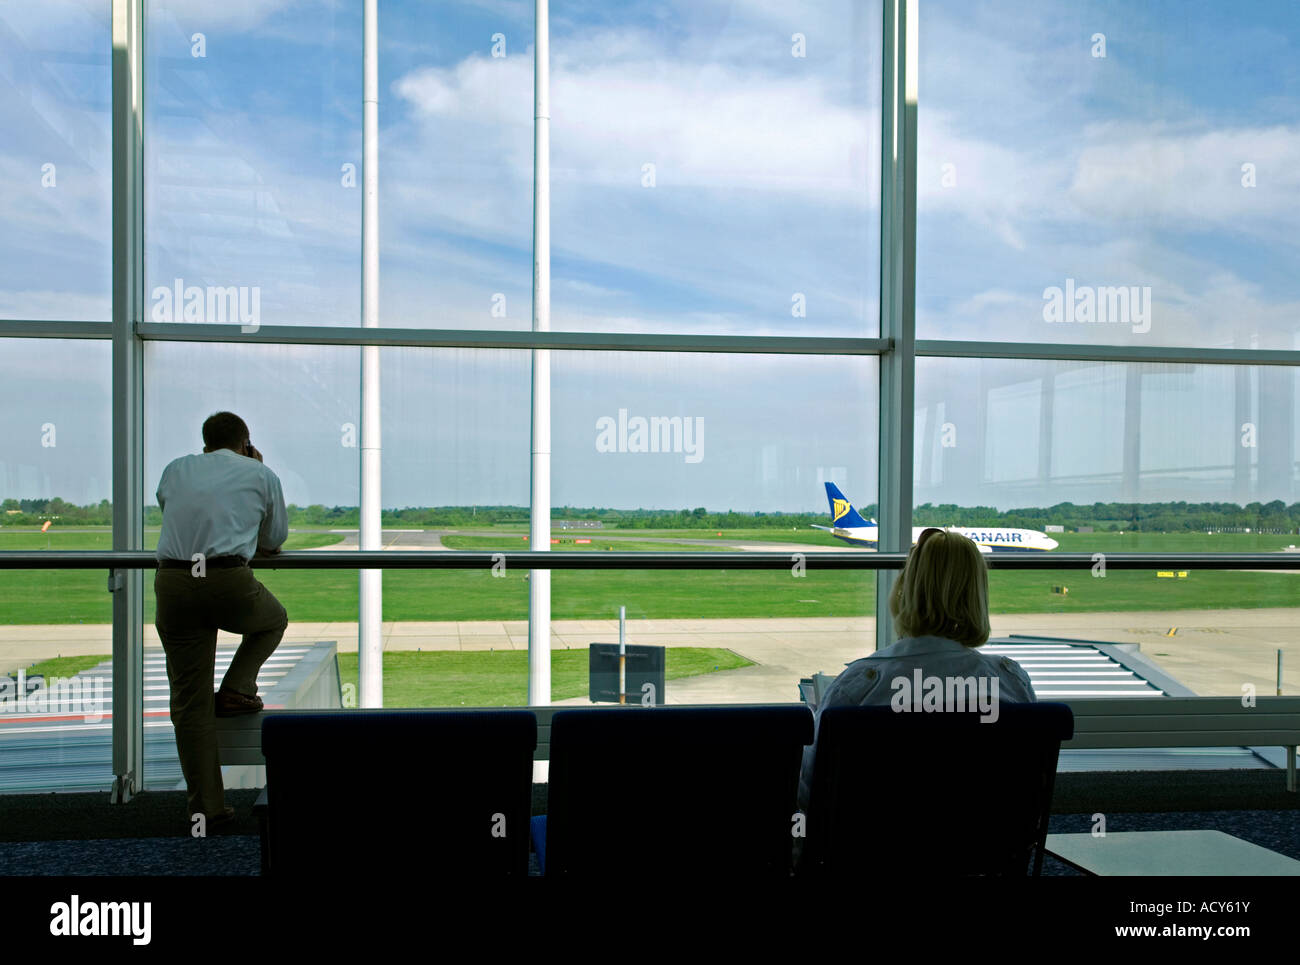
0,527 -> 1300,624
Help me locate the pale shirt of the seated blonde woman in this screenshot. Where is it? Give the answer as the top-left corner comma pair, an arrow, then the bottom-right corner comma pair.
800,637 -> 1037,810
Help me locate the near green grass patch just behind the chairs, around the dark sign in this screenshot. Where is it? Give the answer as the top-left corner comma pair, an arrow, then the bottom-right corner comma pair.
338,646 -> 751,707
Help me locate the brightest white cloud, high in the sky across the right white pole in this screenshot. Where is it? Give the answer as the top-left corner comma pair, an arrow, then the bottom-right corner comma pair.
394,31 -> 878,201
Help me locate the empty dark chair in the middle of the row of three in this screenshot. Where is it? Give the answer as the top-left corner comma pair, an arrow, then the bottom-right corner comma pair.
538,705 -> 813,877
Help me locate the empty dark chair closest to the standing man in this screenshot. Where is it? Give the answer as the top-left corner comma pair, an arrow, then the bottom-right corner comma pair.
261,710 -> 537,880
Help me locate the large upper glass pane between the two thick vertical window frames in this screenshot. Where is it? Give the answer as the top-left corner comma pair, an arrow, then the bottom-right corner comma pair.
146,0 -> 881,334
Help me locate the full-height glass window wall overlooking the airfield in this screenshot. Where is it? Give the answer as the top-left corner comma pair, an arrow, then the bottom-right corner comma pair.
0,0 -> 1300,788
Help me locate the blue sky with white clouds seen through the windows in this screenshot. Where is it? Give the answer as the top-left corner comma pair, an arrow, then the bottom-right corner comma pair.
0,0 -> 1300,511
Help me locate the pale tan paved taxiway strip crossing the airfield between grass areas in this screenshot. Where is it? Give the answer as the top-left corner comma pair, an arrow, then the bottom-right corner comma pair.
0,609 -> 1300,700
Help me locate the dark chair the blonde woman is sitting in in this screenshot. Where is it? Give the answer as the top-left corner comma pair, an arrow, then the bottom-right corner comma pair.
798,704 -> 1074,877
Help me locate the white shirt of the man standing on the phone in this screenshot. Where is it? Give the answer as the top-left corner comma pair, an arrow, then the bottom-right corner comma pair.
157,449 -> 289,559
